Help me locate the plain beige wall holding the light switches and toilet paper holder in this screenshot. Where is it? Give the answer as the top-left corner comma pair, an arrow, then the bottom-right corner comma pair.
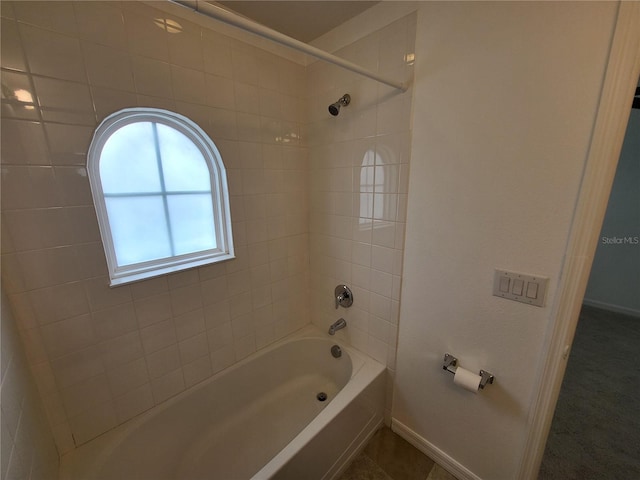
393,2 -> 617,480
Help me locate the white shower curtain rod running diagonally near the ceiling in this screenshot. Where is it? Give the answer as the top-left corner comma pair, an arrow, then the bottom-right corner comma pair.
169,0 -> 407,92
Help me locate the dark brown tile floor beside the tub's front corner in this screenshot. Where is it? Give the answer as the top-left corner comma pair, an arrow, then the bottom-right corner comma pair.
339,427 -> 456,480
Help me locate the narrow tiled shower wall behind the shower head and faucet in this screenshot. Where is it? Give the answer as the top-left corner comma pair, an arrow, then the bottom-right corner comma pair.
308,14 -> 416,419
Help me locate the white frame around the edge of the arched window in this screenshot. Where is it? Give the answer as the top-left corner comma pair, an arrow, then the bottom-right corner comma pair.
87,108 -> 235,286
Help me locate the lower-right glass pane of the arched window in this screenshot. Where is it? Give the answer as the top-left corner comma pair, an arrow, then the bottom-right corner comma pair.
167,194 -> 217,255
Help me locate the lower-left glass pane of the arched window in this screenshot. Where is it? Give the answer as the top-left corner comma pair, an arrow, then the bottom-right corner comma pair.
105,195 -> 171,266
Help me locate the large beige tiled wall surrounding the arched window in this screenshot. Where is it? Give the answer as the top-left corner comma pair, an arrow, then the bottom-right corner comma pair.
1,1 -> 309,453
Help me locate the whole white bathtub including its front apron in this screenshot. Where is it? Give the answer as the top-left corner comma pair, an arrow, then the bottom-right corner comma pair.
61,327 -> 385,480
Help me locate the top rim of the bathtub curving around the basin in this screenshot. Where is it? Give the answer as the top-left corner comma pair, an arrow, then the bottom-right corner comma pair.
59,324 -> 386,480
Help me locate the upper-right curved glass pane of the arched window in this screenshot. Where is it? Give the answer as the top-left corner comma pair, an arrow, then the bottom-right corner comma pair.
157,123 -> 211,192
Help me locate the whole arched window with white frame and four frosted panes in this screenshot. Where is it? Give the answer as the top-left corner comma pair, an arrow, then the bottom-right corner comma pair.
87,108 -> 233,285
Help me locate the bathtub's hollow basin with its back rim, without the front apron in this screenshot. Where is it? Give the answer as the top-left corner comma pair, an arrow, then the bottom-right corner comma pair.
62,327 -> 382,480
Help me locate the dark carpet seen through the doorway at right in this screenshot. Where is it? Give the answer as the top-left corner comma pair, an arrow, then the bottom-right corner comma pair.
538,307 -> 640,480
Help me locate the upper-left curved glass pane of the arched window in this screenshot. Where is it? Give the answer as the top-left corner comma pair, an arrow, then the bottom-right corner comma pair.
100,122 -> 161,194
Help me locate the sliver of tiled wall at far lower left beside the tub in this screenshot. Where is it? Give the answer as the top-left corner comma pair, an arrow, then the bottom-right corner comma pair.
0,291 -> 58,480
